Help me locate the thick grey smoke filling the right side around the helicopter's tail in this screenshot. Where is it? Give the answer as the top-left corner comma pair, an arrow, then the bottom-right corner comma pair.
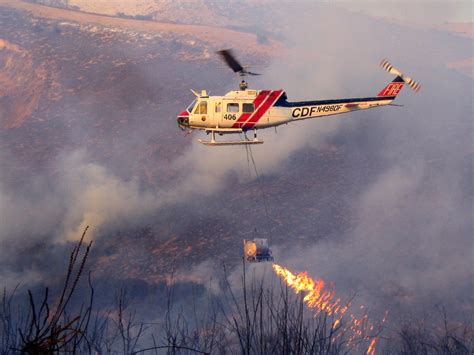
262,0 -> 474,318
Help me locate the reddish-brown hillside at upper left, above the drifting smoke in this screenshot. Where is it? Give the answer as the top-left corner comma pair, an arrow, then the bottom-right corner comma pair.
0,0 -> 279,177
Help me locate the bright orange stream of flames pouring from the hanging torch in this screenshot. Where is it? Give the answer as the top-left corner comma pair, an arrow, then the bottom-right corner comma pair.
272,264 -> 386,354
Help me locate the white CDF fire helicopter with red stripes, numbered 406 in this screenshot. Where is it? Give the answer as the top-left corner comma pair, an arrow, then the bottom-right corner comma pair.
177,49 -> 421,146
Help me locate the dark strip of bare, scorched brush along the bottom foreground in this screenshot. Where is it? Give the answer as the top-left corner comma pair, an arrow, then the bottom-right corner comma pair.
0,228 -> 474,354
